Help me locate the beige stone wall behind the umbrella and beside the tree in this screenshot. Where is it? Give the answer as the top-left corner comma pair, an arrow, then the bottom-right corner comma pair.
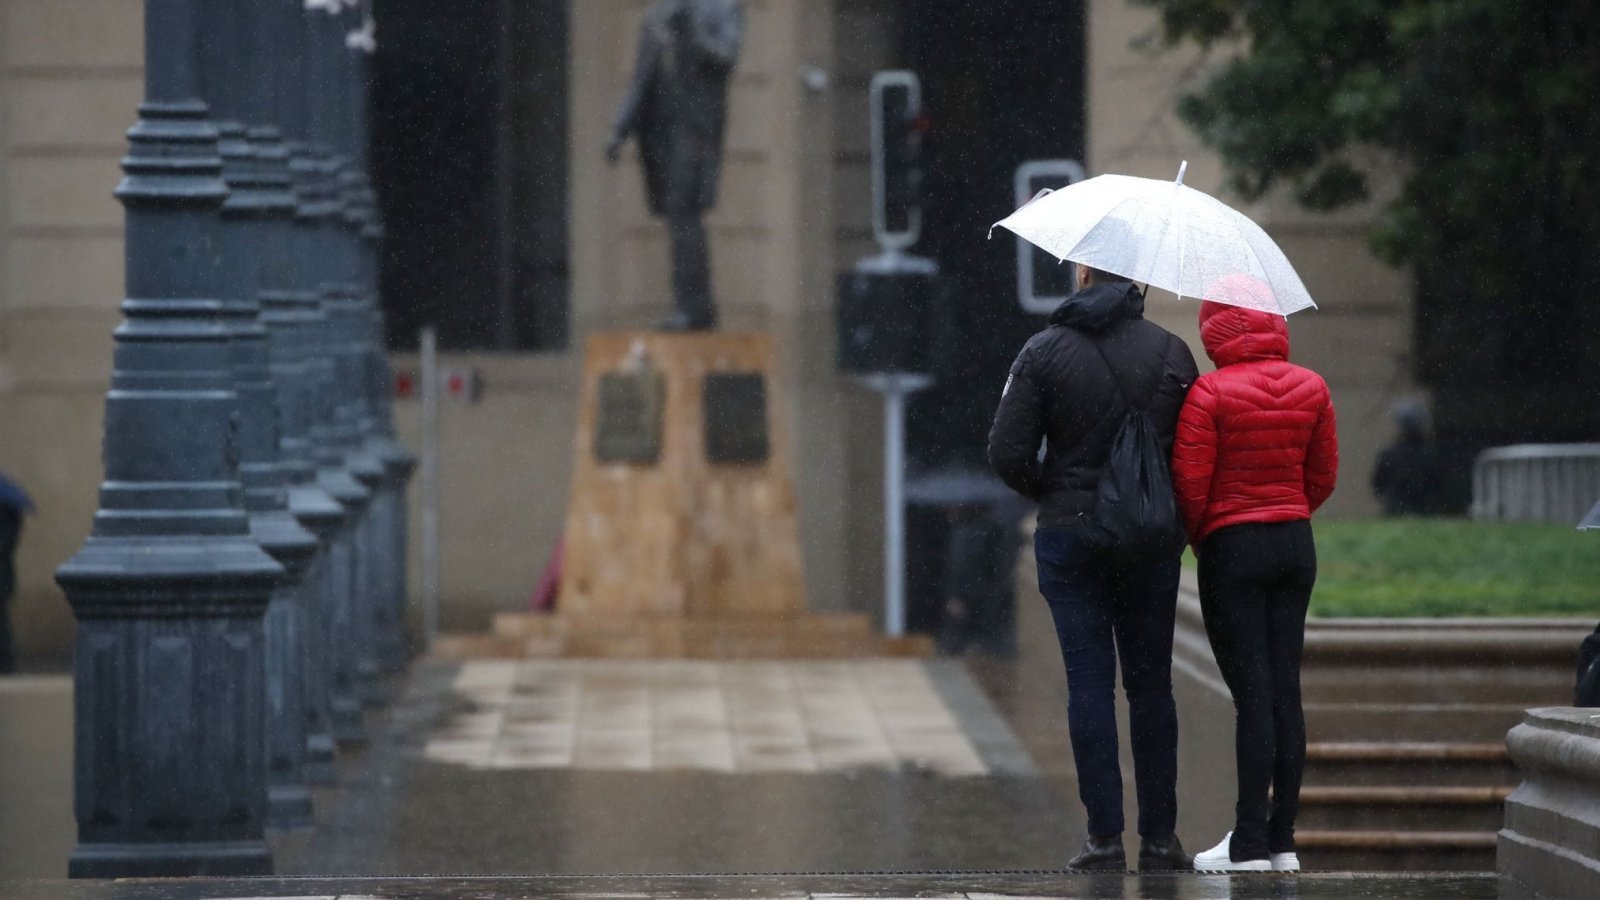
1086,0 -> 1421,516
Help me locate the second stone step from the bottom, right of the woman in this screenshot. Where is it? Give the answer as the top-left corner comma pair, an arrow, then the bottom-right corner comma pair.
1296,785 -> 1510,836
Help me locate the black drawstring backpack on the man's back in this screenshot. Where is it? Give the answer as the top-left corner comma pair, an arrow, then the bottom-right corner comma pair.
1085,338 -> 1187,562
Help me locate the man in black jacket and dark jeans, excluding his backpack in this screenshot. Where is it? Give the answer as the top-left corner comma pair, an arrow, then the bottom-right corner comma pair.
989,264 -> 1197,871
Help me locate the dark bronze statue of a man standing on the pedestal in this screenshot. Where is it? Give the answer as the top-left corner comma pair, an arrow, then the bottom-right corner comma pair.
606,0 -> 744,331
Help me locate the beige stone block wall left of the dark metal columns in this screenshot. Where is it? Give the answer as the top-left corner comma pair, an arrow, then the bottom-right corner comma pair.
0,0 -> 144,660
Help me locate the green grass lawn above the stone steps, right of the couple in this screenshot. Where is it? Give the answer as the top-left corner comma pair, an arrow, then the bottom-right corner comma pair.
1187,519 -> 1600,618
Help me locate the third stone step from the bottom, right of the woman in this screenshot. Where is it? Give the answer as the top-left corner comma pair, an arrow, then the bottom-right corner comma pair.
1304,741 -> 1517,786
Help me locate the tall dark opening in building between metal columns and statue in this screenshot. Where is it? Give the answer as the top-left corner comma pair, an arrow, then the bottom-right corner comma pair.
371,0 -> 568,351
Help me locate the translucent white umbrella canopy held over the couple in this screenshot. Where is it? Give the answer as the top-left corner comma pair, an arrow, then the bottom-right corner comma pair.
989,162 -> 1317,315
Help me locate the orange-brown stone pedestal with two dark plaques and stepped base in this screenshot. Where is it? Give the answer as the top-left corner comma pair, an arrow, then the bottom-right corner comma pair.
473,331 -> 923,658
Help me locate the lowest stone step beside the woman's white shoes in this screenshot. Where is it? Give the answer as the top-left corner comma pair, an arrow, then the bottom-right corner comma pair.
1294,830 -> 1496,871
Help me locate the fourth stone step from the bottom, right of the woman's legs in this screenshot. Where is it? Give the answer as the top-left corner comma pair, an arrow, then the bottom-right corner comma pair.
1306,703 -> 1525,743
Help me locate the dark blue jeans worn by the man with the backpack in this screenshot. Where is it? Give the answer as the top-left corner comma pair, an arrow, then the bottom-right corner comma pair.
1034,525 -> 1178,838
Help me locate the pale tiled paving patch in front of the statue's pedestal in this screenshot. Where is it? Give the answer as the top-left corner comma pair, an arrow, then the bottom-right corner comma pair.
429,660 -> 1011,777
